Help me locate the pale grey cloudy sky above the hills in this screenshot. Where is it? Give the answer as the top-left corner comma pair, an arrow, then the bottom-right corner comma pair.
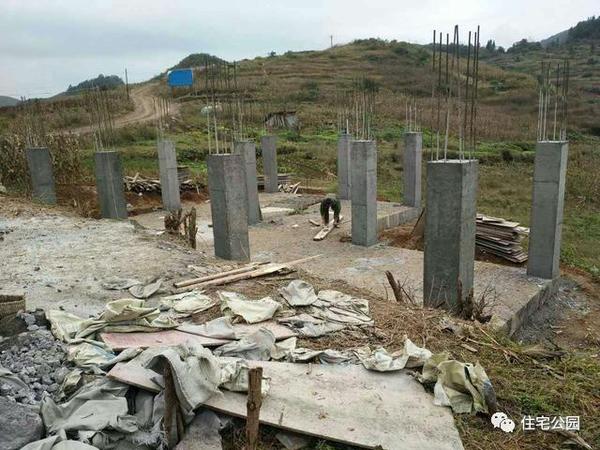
0,0 -> 600,97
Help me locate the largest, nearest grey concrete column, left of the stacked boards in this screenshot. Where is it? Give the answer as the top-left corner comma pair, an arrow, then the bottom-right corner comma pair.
423,160 -> 478,310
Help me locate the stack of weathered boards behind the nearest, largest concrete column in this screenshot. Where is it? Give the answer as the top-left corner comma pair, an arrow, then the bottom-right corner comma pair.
475,214 -> 529,263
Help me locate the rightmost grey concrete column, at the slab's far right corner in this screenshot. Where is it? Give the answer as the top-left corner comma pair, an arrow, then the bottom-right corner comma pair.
527,141 -> 569,279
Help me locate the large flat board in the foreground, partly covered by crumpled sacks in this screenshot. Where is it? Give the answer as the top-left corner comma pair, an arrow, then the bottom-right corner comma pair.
205,361 -> 463,450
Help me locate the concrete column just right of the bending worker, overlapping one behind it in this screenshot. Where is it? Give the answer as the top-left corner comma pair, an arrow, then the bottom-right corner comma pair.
350,141 -> 377,247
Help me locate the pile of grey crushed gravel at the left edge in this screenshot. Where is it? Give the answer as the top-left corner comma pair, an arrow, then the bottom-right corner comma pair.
0,325 -> 69,404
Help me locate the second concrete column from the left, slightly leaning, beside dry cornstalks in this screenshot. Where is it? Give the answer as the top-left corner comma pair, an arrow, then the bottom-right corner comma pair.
95,151 -> 127,219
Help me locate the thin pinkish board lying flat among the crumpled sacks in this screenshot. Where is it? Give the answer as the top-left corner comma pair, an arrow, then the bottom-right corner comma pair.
100,330 -> 230,351
